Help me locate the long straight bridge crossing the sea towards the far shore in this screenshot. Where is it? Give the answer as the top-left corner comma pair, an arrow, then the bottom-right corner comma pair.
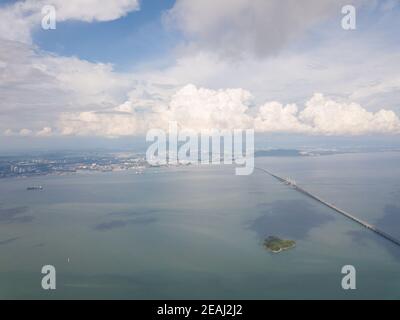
255,167 -> 400,246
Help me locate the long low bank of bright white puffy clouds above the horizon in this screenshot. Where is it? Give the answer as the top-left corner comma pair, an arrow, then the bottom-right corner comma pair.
59,85 -> 400,137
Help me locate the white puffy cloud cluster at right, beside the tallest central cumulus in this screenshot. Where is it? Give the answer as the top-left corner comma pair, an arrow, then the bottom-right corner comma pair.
255,94 -> 400,135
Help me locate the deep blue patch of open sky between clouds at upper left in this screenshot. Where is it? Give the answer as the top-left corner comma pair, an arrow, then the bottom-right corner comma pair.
33,0 -> 178,71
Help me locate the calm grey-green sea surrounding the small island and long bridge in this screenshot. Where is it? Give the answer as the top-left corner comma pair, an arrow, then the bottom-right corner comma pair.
0,153 -> 400,299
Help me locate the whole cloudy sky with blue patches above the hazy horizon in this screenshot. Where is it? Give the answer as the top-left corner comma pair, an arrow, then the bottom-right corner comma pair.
0,0 -> 400,150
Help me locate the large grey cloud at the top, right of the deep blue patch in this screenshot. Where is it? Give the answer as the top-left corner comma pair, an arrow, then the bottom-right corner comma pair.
166,0 -> 365,57
